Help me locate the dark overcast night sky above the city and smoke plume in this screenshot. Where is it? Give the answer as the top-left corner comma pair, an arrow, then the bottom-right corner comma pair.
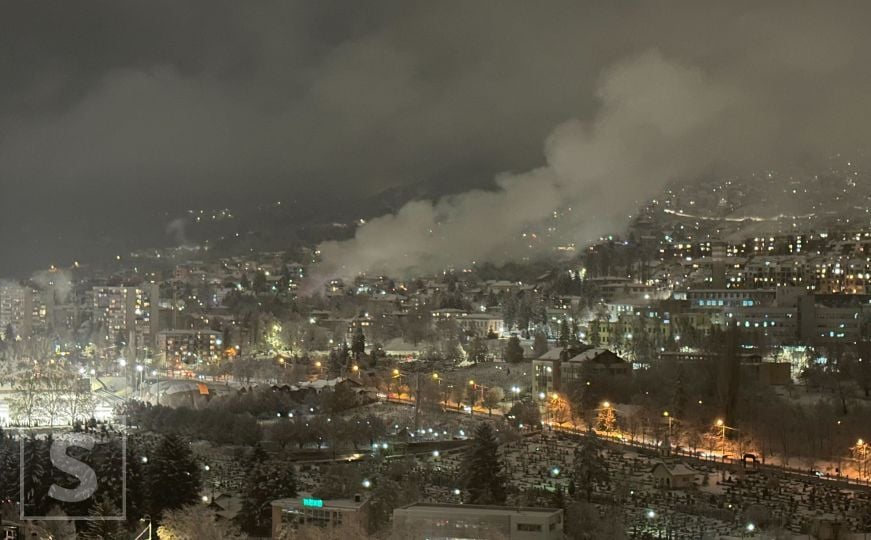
0,1 -> 871,273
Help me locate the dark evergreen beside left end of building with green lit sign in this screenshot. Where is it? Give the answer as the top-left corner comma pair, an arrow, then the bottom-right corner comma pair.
236,462 -> 296,536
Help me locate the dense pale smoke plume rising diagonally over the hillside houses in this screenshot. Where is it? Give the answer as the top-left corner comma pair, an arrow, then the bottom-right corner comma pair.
316,52 -> 743,279
